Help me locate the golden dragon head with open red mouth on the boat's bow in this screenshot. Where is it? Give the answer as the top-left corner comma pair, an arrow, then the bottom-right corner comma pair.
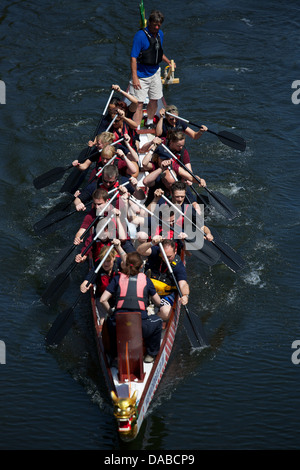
111,390 -> 138,440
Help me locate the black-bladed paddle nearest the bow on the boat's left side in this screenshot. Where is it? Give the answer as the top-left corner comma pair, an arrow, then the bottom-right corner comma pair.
45,245 -> 114,346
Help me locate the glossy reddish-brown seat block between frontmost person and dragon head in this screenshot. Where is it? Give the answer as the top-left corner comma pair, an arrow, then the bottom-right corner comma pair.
116,312 -> 145,382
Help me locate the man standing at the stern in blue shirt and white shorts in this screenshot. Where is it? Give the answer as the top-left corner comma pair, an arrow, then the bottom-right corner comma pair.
129,10 -> 171,128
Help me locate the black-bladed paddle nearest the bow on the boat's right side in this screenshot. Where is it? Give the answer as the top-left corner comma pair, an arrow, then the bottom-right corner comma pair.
159,243 -> 208,349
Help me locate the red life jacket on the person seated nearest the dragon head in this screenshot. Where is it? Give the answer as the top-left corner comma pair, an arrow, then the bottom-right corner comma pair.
116,273 -> 148,311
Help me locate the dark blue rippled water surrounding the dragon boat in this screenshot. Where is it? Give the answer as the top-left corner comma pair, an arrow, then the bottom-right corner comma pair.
0,0 -> 300,451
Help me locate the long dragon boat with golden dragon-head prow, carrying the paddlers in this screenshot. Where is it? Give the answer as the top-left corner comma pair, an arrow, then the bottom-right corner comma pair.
90,100 -> 185,442
